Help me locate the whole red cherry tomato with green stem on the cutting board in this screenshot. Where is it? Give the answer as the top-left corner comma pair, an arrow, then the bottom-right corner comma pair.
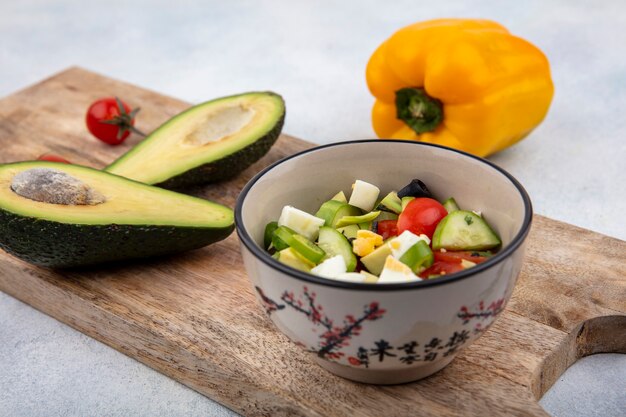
85,97 -> 145,145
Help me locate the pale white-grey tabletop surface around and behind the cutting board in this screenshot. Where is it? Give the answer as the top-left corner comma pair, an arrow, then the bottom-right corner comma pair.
0,0 -> 626,415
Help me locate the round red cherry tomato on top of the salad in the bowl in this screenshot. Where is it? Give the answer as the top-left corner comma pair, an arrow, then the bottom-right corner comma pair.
398,197 -> 448,239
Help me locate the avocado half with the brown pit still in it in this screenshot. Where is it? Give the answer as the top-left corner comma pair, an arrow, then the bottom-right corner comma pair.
0,161 -> 234,268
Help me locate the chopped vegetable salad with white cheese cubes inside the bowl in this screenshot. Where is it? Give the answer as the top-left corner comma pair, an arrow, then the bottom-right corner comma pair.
264,179 -> 502,284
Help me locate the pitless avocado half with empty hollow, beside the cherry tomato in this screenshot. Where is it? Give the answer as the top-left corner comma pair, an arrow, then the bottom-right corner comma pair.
105,92 -> 285,188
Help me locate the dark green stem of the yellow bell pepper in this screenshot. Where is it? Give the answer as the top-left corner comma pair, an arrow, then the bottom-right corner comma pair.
396,87 -> 443,134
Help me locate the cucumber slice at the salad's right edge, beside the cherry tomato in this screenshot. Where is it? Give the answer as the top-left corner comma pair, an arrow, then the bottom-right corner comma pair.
432,210 -> 502,250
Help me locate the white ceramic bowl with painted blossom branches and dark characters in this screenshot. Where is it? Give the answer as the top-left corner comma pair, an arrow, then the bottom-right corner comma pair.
235,140 -> 532,384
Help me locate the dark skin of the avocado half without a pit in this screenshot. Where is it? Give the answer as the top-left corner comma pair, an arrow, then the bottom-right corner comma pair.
154,112 -> 285,189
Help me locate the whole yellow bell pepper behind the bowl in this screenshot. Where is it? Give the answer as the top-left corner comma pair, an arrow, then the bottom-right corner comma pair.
366,19 -> 554,156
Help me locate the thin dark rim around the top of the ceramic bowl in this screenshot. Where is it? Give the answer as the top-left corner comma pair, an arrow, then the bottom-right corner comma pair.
235,139 -> 533,291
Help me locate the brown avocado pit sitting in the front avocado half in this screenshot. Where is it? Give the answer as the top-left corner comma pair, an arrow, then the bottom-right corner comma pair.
11,168 -> 106,206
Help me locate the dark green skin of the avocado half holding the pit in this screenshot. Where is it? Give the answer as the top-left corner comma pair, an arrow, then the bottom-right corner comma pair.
0,209 -> 235,268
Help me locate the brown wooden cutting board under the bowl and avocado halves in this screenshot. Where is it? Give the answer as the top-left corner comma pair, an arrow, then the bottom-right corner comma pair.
0,68 -> 626,416
